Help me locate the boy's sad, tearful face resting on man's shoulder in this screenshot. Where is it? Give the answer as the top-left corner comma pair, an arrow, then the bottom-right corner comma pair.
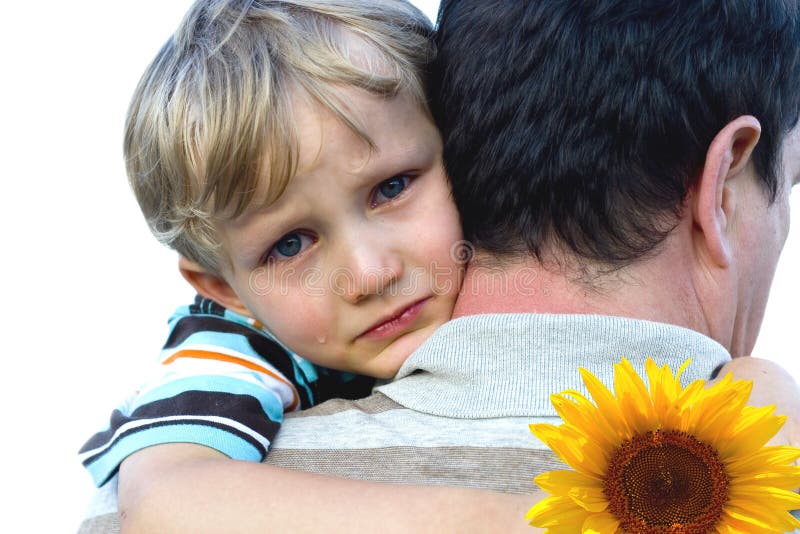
220,89 -> 462,378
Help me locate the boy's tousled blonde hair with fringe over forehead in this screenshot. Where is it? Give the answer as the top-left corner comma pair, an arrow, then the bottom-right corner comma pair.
124,0 -> 432,274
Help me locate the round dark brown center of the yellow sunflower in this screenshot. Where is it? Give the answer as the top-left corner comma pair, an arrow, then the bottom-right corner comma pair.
603,431 -> 728,534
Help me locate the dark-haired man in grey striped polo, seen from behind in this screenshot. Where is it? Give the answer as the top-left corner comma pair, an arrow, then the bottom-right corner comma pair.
83,0 -> 800,530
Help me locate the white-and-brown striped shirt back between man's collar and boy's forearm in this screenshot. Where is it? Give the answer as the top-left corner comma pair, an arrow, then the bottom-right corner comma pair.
265,392 -> 563,493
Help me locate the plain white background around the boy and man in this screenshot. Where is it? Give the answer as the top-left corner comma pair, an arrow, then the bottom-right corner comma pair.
0,0 -> 800,532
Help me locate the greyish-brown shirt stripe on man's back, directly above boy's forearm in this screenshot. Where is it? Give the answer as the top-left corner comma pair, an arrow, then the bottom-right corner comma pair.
266,447 -> 566,494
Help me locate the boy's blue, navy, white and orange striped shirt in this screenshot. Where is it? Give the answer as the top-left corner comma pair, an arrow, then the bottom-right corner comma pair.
79,296 -> 372,486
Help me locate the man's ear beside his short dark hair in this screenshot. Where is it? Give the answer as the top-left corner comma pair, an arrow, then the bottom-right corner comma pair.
692,115 -> 761,267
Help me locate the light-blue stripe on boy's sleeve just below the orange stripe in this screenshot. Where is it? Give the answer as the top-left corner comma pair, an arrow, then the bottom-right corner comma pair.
130,371 -> 283,423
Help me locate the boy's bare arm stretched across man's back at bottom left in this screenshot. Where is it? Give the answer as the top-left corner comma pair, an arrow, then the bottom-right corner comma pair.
119,443 -> 544,533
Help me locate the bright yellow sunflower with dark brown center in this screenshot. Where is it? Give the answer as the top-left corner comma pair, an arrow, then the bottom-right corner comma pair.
526,359 -> 800,534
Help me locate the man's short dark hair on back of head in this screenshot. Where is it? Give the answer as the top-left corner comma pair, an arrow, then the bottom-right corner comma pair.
430,0 -> 800,267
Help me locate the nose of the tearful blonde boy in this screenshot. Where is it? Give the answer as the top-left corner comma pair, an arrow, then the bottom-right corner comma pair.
332,233 -> 403,304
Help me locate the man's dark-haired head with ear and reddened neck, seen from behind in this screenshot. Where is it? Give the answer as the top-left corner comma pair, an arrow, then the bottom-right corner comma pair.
430,0 -> 800,360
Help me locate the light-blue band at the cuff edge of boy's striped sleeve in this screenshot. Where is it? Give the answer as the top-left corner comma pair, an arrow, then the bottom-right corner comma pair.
86,424 -> 264,486
